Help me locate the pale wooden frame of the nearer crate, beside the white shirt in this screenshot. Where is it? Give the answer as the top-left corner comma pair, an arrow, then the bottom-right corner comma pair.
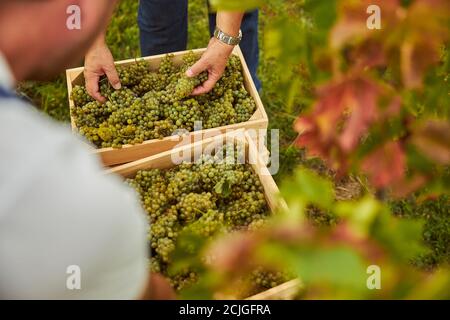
107,130 -> 301,300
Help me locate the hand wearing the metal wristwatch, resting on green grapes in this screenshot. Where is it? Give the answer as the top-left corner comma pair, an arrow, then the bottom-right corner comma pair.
186,38 -> 233,96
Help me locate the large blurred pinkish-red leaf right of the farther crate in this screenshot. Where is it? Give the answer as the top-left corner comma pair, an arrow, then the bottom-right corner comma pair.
295,75 -> 380,162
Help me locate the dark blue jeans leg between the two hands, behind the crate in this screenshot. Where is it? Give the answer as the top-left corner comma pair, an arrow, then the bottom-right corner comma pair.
138,0 -> 188,56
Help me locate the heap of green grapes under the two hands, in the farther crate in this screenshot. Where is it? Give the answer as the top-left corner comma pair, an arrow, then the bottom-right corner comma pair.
71,52 -> 256,148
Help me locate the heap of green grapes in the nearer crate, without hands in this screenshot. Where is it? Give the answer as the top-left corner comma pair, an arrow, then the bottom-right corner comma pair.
127,144 -> 269,289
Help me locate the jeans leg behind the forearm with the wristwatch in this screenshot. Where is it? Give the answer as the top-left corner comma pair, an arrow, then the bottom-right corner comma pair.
209,10 -> 261,91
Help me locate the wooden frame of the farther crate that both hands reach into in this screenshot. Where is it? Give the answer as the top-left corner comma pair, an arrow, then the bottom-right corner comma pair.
66,46 -> 268,166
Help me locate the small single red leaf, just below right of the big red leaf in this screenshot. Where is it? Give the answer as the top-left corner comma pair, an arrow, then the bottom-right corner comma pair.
362,141 -> 406,189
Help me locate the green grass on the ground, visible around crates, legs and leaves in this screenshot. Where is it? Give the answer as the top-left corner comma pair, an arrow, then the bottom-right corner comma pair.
20,0 -> 450,269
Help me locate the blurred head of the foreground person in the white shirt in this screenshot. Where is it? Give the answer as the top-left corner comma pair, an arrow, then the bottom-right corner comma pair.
0,0 -> 117,81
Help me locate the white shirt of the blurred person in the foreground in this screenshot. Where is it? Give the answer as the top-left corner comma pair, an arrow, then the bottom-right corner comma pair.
0,54 -> 149,299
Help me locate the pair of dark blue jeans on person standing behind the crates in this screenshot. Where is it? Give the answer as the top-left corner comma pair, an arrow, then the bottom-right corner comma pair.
138,0 -> 261,90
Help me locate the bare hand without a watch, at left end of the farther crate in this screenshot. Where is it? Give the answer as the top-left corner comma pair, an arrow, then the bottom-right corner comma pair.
84,41 -> 121,102
